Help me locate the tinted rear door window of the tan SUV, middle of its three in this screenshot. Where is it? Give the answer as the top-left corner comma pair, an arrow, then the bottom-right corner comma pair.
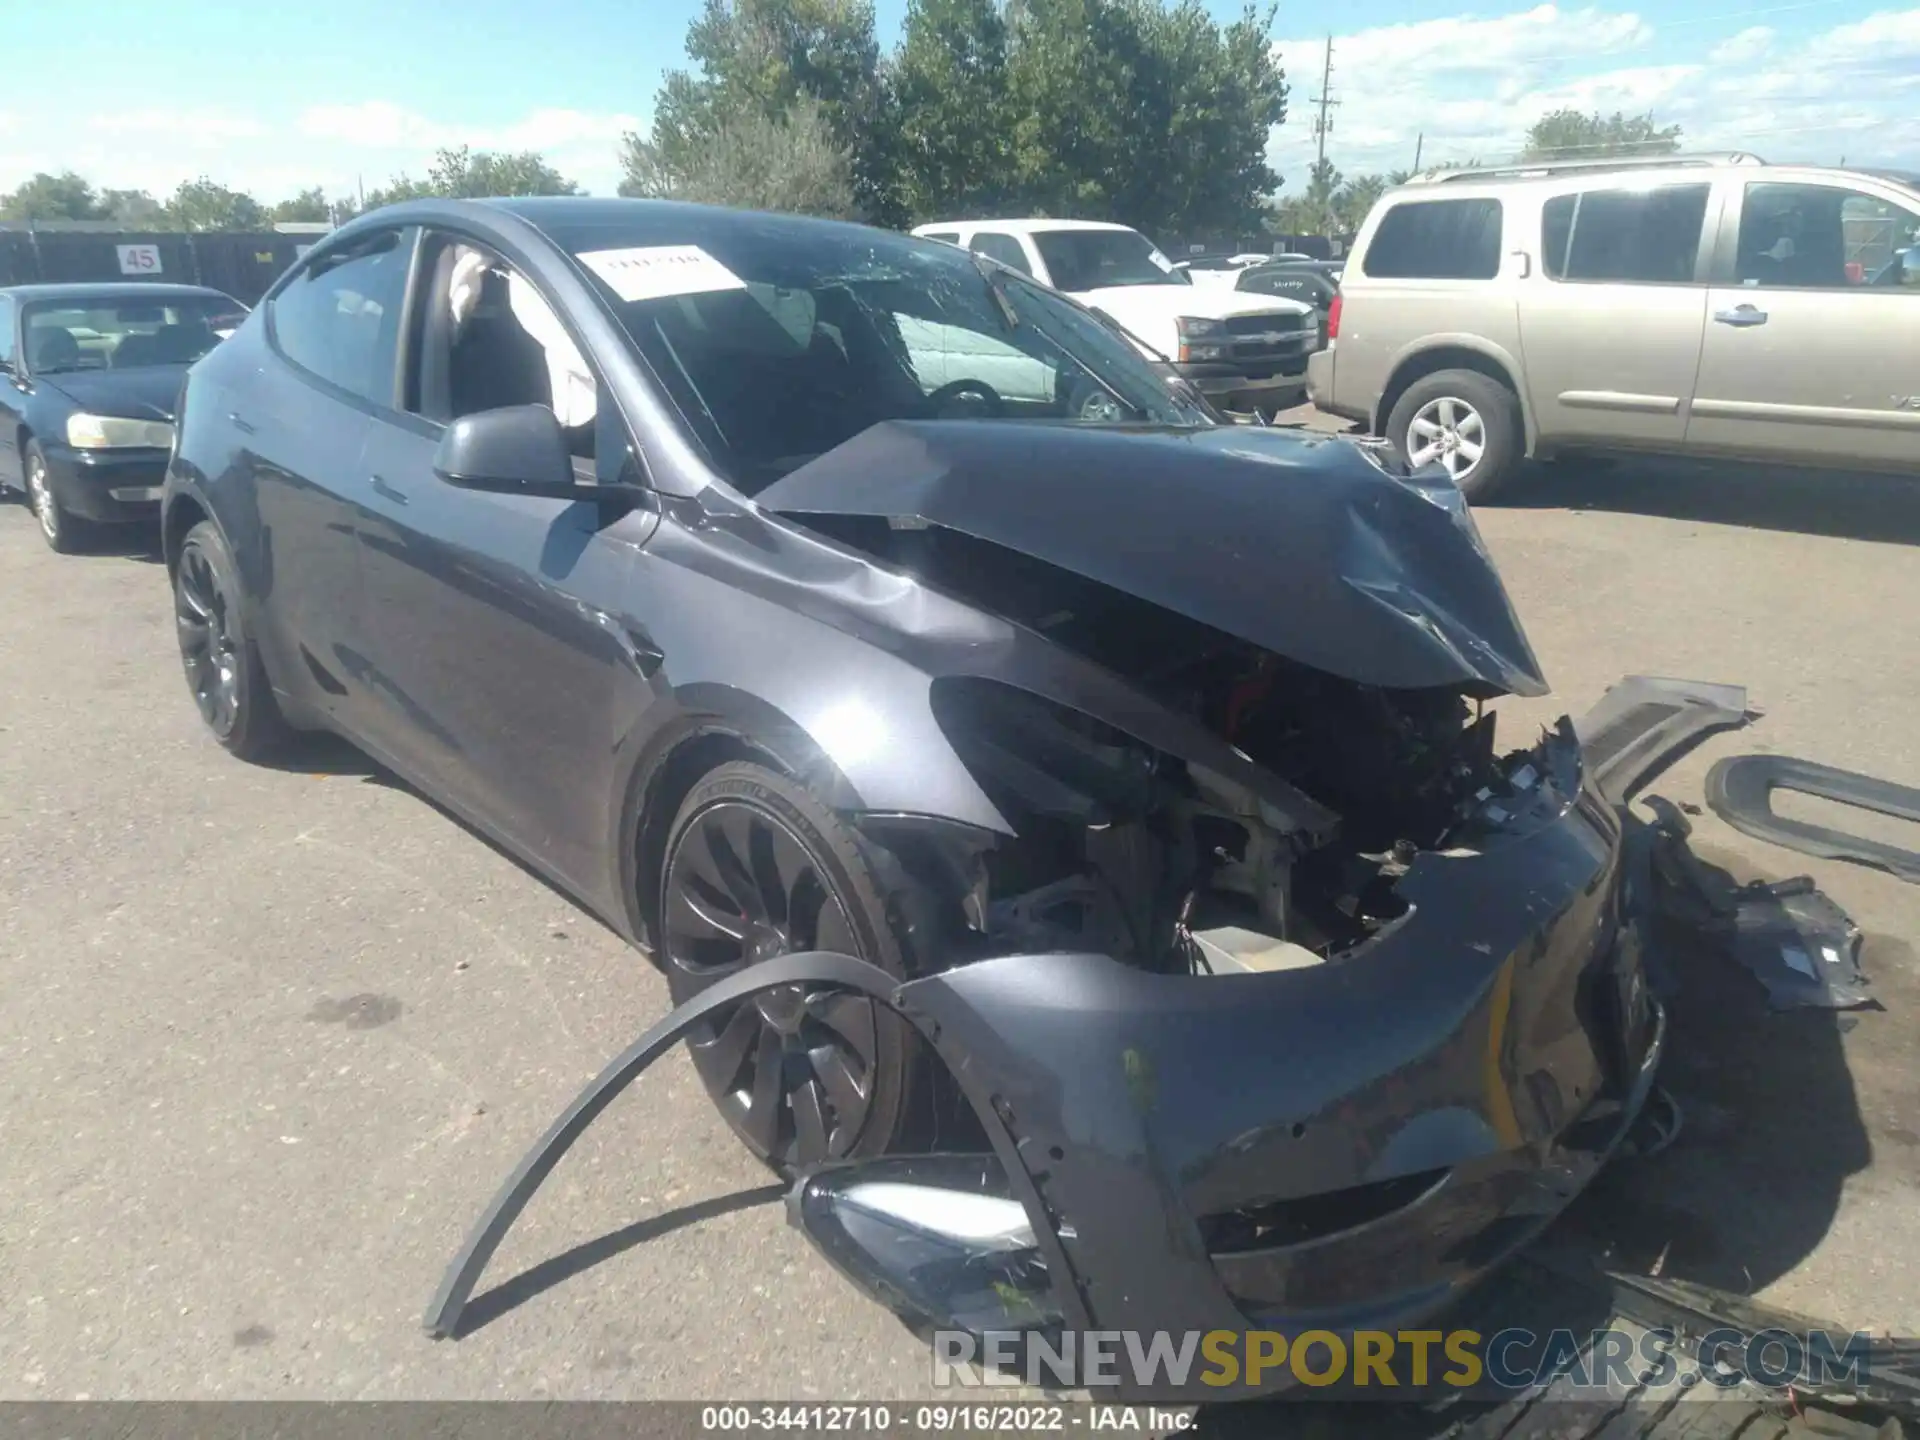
1540,184 -> 1713,284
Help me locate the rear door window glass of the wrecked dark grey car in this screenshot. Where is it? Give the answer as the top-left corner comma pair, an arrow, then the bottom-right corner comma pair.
269,230 -> 413,405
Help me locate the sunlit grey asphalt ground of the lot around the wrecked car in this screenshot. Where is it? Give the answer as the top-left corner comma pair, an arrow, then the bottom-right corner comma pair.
0,443 -> 1920,1400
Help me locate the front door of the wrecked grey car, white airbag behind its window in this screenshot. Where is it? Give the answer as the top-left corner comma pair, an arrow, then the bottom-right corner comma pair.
361,236 -> 659,891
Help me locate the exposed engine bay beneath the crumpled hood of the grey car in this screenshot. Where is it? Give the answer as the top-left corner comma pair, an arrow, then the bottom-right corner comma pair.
808,516 -> 1540,973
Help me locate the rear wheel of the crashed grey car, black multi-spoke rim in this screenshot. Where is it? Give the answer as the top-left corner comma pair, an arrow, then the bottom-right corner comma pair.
173,520 -> 294,760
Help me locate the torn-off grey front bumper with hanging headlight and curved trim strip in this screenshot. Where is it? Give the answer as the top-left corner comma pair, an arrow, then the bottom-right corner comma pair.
426,724 -> 1665,1400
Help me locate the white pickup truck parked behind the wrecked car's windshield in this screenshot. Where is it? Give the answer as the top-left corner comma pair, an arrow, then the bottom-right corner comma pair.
914,221 -> 1319,413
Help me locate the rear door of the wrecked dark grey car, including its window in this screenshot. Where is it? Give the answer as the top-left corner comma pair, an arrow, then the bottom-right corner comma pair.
245,227 -> 417,730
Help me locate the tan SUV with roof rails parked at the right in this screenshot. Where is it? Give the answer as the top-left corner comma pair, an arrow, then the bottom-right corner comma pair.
1308,156 -> 1920,499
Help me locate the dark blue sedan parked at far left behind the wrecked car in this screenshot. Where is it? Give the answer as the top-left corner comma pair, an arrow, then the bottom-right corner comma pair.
0,284 -> 246,551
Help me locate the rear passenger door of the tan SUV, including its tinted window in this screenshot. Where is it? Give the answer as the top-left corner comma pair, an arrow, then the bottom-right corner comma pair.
1519,177 -> 1713,449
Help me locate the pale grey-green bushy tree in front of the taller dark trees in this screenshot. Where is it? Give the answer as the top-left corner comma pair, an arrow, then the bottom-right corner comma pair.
620,96 -> 858,219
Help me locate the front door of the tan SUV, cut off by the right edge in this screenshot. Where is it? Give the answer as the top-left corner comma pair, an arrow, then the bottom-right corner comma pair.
1686,177 -> 1920,467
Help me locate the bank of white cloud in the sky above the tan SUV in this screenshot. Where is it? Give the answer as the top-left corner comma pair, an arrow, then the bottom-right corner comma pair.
1271,4 -> 1920,188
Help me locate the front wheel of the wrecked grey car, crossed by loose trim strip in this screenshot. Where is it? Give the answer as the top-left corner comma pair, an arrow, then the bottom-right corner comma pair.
657,760 -> 933,1175
